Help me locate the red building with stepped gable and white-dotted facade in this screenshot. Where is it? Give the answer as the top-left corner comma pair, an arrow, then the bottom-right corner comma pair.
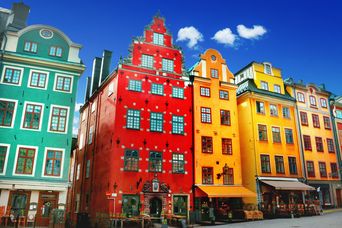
71,17 -> 193,222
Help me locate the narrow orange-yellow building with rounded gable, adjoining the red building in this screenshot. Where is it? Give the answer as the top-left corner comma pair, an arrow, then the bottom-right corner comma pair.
190,49 -> 256,220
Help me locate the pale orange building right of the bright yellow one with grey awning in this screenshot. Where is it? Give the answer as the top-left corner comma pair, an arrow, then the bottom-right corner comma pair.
286,79 -> 341,207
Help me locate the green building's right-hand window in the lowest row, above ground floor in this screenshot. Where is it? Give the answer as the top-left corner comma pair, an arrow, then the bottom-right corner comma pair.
44,150 -> 63,176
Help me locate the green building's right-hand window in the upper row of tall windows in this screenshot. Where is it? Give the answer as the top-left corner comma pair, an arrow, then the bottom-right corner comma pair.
50,106 -> 68,132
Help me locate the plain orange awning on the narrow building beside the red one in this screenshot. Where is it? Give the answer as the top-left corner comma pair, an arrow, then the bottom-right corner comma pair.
198,186 -> 256,198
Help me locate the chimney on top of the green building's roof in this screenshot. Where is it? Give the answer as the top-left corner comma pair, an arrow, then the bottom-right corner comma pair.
11,2 -> 30,30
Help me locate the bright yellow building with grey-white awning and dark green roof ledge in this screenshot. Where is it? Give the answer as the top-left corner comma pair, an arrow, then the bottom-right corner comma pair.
235,62 -> 313,214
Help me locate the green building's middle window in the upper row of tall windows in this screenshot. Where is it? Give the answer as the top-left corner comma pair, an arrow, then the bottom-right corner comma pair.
22,103 -> 43,130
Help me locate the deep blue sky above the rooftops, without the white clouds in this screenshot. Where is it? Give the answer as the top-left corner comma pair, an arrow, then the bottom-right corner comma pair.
0,0 -> 342,134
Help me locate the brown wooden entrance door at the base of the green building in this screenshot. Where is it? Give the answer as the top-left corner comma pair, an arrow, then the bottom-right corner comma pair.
36,192 -> 58,226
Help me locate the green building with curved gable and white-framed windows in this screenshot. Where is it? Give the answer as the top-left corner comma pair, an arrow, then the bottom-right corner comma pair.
0,3 -> 85,225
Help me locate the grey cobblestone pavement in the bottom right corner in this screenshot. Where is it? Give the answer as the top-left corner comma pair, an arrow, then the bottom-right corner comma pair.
202,211 -> 342,228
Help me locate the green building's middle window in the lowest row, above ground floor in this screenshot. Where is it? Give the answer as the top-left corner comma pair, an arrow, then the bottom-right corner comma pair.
15,147 -> 36,174
